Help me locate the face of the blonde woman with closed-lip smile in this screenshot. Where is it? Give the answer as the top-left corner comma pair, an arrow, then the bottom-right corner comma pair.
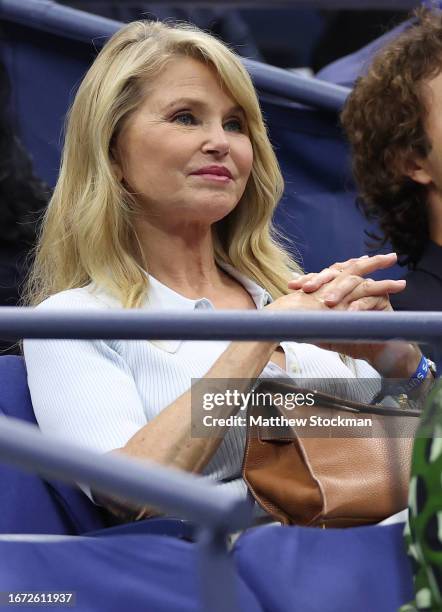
115,57 -> 253,226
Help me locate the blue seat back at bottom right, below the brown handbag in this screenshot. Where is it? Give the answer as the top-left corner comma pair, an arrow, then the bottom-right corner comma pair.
235,523 -> 413,612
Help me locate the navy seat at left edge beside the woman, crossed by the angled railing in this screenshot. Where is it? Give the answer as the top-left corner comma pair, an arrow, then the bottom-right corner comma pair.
0,356 -> 107,535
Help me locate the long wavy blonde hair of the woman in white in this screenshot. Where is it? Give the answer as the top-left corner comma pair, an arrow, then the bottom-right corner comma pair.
24,21 -> 299,308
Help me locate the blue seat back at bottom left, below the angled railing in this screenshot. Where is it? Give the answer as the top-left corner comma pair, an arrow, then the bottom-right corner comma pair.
0,535 -> 263,612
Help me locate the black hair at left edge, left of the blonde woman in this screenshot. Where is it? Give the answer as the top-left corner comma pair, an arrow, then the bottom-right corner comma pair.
0,57 -> 50,249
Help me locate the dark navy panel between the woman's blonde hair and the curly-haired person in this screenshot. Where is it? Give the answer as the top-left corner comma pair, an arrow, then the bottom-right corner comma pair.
261,95 -> 403,278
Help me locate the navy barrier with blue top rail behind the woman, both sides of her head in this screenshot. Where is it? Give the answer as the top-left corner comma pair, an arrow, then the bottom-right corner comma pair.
0,0 -> 403,278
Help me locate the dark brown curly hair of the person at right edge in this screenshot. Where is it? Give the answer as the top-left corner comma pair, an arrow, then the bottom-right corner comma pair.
341,9 -> 442,268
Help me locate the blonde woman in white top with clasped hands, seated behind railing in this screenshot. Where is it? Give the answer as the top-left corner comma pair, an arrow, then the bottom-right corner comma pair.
24,21 -> 421,519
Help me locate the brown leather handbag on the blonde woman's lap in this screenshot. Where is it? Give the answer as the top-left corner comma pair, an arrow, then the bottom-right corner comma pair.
243,379 -> 420,527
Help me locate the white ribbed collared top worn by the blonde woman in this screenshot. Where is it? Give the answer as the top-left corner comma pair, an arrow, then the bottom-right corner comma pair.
24,265 -> 380,506
